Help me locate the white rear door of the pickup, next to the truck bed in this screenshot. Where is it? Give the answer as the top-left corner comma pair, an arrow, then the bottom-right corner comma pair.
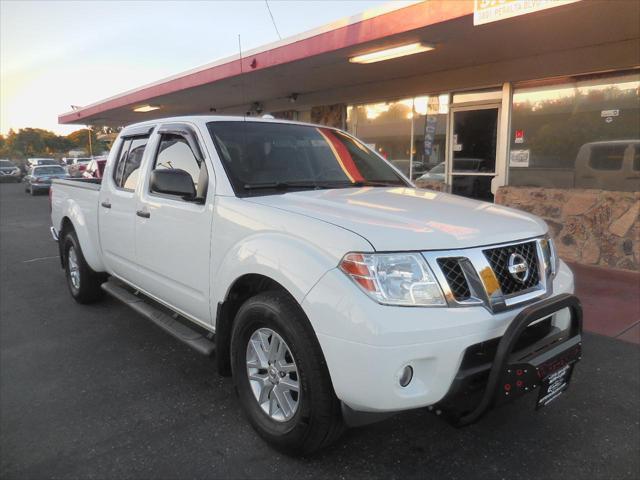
98,127 -> 154,284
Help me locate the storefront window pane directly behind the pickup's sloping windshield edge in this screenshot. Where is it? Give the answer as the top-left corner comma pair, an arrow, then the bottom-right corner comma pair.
347,98 -> 413,175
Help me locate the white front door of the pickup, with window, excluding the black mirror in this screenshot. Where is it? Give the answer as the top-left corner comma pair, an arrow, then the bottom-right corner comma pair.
135,123 -> 214,324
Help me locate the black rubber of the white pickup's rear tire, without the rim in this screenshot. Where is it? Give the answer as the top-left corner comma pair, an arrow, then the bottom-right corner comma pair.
61,230 -> 106,304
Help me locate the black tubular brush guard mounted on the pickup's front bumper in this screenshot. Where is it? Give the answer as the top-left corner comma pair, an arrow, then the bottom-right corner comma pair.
435,294 -> 582,426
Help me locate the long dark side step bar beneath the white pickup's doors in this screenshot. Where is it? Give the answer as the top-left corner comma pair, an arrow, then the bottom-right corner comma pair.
102,278 -> 215,356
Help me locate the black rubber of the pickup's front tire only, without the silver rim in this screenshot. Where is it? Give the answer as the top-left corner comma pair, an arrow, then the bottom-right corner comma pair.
231,291 -> 344,455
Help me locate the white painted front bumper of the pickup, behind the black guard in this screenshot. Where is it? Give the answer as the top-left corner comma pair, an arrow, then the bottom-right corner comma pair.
302,263 -> 574,413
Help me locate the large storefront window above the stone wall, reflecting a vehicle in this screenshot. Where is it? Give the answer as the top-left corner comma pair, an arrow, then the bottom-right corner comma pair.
509,73 -> 640,191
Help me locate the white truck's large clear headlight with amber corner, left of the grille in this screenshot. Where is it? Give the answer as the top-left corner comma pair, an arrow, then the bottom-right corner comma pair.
340,253 -> 447,307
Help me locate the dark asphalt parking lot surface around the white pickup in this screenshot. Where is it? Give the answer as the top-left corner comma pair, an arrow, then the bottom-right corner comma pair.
0,184 -> 640,479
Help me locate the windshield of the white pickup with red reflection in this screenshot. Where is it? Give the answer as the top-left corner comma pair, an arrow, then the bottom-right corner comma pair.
208,121 -> 408,195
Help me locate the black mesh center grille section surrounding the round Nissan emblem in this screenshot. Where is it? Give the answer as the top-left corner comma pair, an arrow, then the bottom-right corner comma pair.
483,242 -> 540,295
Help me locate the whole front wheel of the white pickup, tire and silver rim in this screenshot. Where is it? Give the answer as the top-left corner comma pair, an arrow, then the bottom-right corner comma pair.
231,292 -> 344,454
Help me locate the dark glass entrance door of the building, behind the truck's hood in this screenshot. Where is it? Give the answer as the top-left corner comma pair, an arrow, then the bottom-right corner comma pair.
447,105 -> 500,202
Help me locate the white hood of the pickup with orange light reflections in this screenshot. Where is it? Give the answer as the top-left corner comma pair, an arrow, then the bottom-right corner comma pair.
246,187 -> 547,251
